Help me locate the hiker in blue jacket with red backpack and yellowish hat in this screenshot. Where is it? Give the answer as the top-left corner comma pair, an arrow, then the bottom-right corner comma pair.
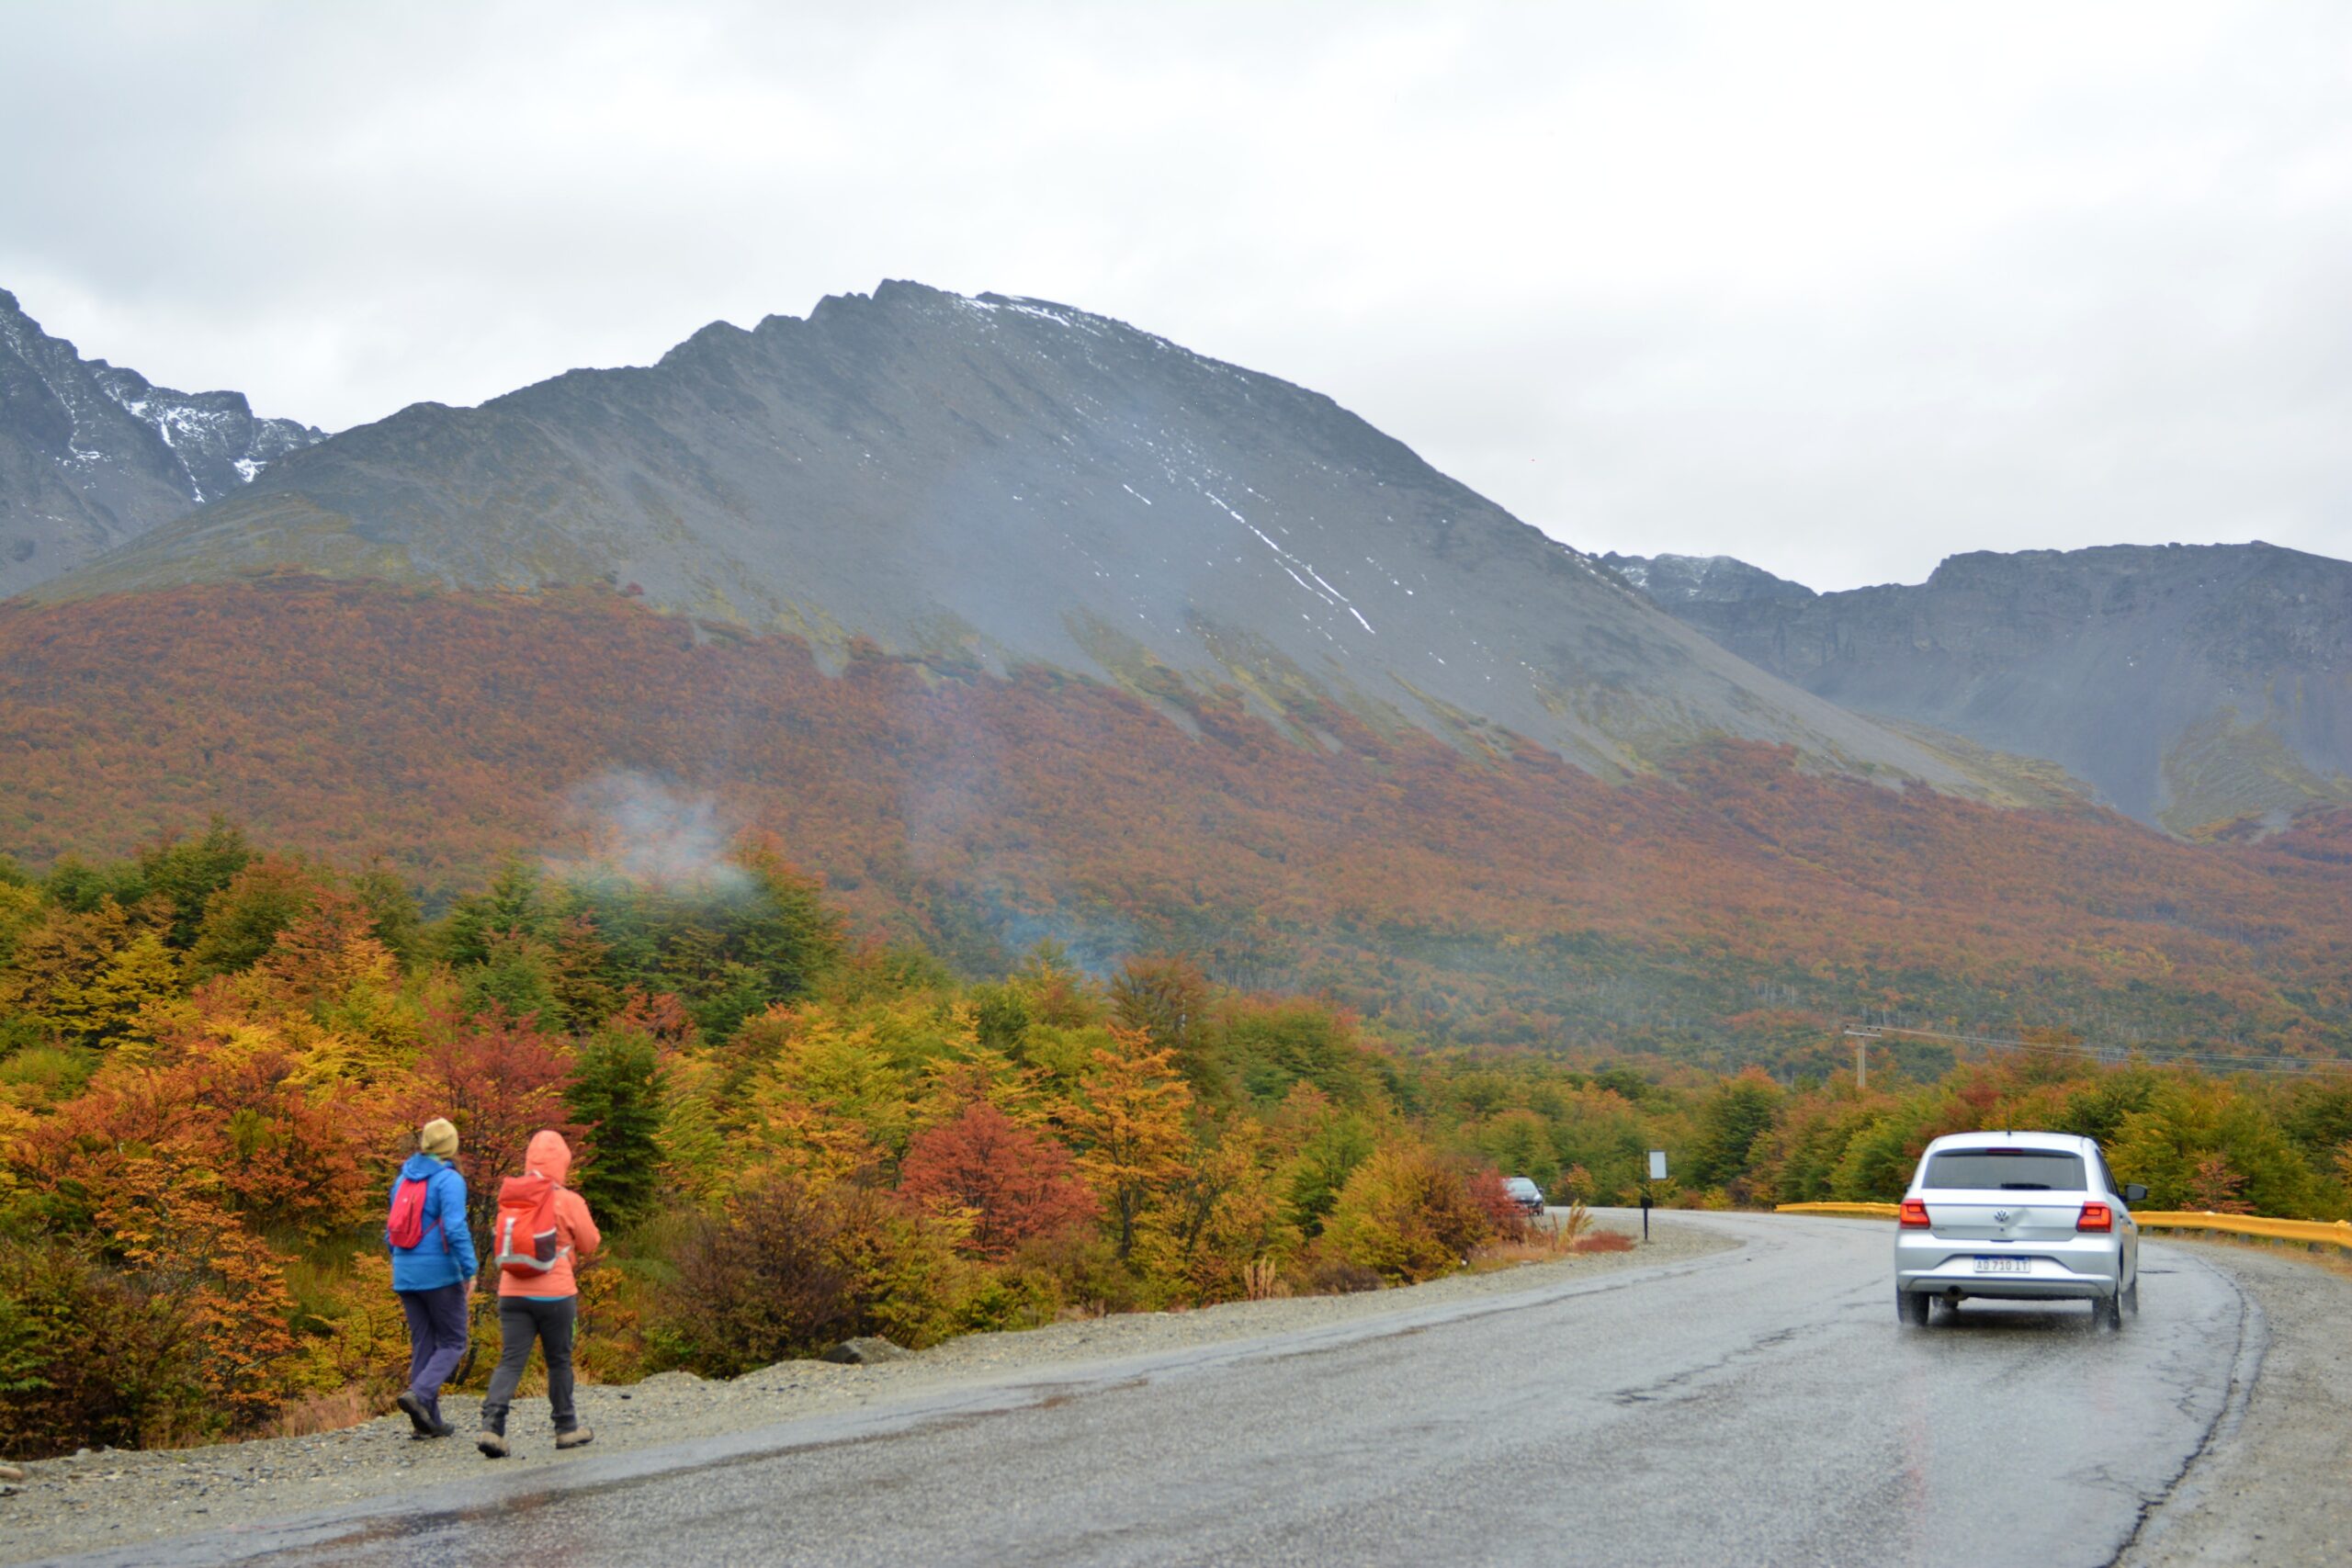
383,1117 -> 478,1437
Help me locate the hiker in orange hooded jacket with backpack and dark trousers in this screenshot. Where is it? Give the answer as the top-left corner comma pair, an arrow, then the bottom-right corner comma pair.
475,1131 -> 605,1460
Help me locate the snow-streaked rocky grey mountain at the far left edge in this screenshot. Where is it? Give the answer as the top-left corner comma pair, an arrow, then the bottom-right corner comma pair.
0,289 -> 322,594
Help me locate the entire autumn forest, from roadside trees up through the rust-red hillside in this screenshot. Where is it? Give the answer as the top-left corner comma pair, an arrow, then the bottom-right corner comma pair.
0,579 -> 2352,1455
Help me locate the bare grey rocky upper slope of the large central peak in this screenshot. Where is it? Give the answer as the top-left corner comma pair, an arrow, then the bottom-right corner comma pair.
42,282 -> 1973,787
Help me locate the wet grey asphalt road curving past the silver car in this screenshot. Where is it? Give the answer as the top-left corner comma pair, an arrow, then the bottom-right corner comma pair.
59,1215 -> 2251,1568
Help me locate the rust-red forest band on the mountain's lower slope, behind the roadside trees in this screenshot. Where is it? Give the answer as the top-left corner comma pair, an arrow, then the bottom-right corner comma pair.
0,576 -> 2352,1067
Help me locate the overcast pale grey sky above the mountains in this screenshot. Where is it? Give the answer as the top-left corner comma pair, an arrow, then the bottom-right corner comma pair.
0,0 -> 2352,588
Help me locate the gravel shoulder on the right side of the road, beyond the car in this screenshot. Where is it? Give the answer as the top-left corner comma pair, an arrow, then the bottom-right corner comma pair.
2117,1236 -> 2352,1568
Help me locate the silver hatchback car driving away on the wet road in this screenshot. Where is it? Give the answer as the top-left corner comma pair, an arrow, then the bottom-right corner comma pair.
1895,1134 -> 2147,1328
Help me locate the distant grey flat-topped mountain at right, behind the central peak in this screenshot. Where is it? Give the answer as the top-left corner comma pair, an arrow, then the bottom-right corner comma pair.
1621,543 -> 2352,832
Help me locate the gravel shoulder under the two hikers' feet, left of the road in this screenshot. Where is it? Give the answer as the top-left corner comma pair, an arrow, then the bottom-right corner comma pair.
0,1215 -> 1738,1563
